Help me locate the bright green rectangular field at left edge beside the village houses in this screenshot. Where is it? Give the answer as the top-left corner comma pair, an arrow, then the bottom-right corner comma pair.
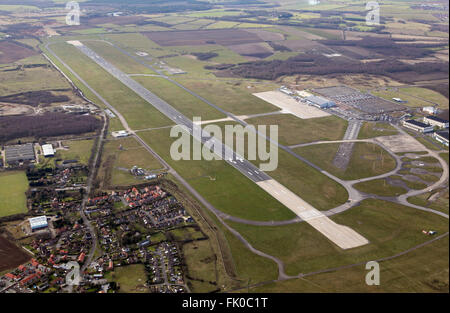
0,172 -> 28,217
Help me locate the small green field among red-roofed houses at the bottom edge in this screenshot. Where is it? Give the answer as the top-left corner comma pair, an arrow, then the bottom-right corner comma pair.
105,264 -> 148,293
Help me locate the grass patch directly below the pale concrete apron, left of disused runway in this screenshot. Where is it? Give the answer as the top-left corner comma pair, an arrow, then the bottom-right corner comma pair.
246,114 -> 348,145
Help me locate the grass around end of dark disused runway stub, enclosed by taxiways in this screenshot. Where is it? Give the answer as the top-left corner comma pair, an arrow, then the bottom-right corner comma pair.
294,142 -> 396,180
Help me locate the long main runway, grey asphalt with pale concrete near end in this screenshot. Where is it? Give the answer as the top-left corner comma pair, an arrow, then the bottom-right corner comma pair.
68,41 -> 368,249
